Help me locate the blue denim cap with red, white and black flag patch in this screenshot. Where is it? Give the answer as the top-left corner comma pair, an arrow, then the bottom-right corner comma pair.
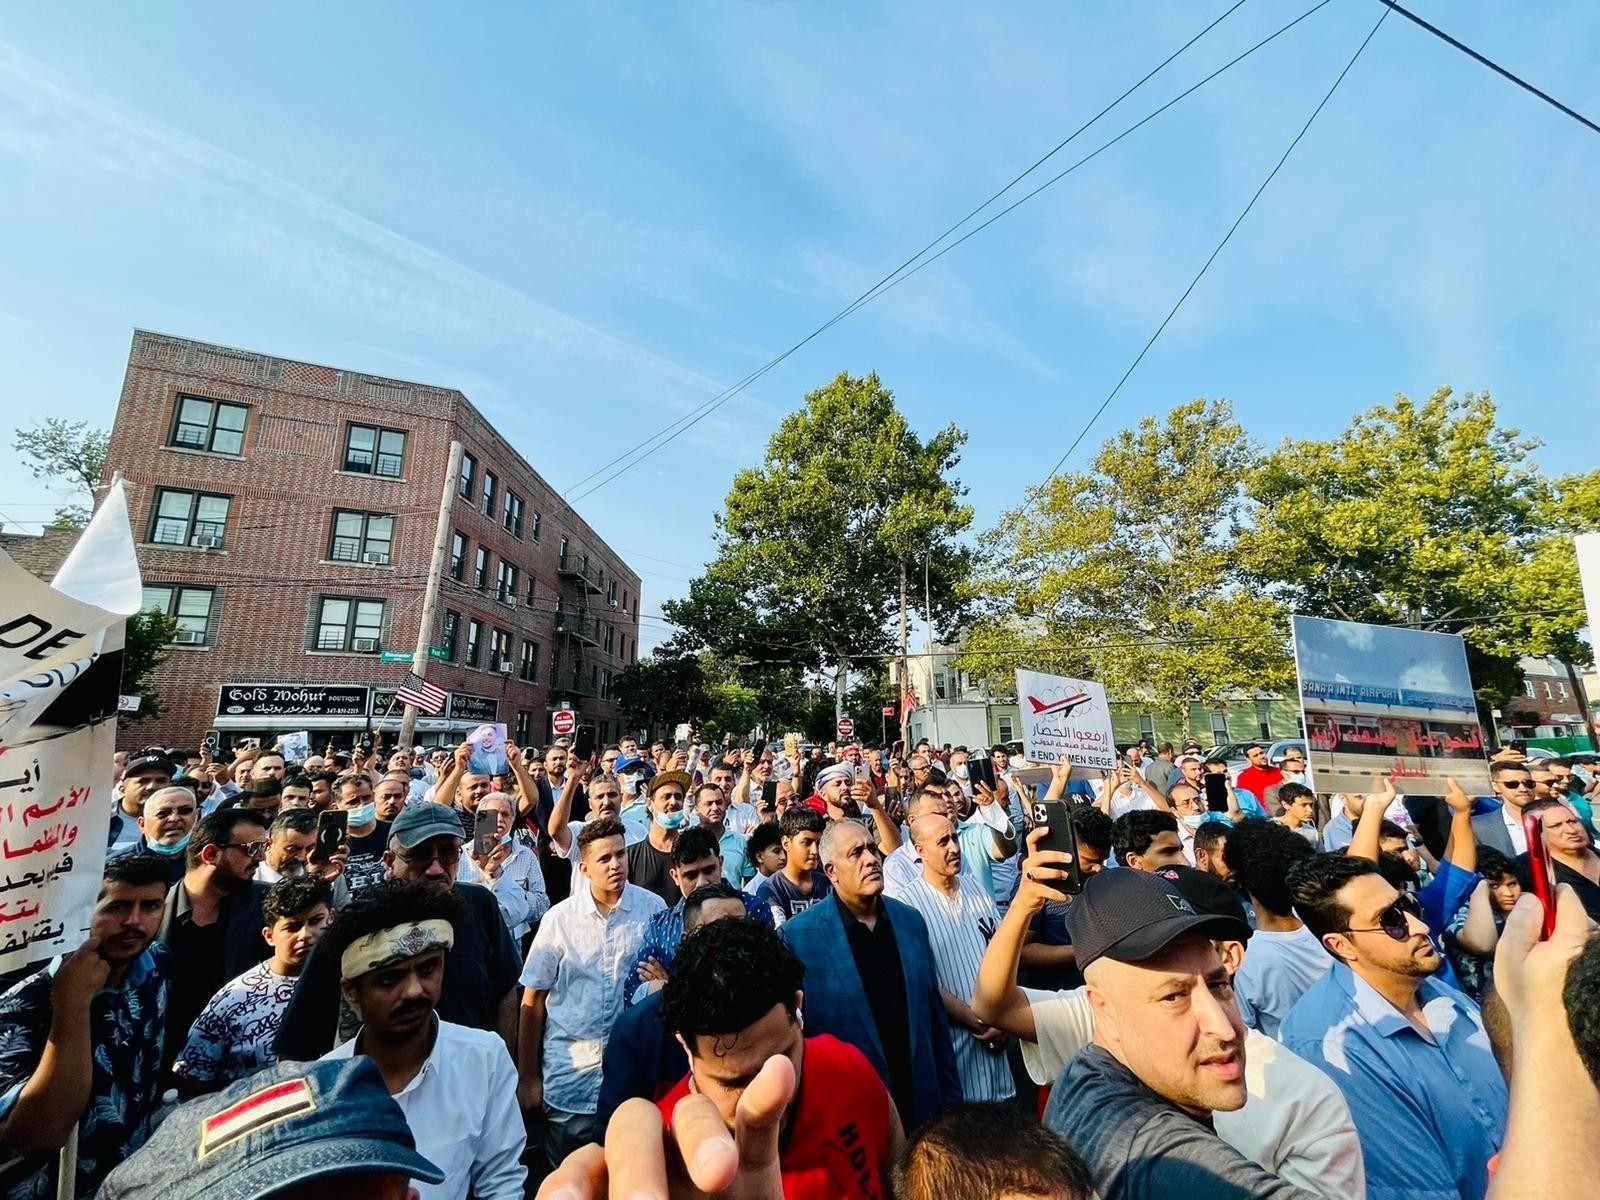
99,1056 -> 445,1200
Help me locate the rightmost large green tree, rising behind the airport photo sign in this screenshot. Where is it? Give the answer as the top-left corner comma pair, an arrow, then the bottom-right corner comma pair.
1242,387 -> 1600,707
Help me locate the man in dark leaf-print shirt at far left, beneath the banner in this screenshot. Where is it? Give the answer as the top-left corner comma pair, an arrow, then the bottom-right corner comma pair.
0,854 -> 170,1198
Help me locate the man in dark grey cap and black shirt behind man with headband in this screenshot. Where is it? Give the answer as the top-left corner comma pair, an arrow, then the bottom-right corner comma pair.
274,805 -> 522,1061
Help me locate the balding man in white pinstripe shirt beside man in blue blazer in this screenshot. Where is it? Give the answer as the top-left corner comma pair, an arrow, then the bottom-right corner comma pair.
890,813 -> 1016,1102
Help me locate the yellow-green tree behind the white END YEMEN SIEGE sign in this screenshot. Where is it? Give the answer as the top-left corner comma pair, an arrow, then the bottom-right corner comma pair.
957,400 -> 1294,729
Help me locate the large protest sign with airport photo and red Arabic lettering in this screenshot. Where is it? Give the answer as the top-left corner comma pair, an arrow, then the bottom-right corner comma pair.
1293,616 -> 1490,795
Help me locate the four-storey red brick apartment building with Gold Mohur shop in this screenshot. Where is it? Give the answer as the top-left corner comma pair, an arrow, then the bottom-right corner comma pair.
96,331 -> 640,746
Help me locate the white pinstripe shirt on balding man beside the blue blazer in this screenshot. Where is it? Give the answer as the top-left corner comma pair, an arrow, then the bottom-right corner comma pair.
894,875 -> 1016,1104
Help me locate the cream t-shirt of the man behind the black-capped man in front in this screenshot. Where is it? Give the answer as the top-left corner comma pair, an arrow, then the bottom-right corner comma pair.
1022,985 -> 1366,1200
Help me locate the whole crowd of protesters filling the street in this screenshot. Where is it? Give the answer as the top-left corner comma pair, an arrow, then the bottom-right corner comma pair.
0,723 -> 1600,1200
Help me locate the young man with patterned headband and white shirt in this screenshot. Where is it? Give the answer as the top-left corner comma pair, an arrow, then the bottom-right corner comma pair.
325,880 -> 528,1200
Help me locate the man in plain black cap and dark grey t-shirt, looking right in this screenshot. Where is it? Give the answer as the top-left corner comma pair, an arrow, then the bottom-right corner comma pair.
1045,870 -> 1315,1200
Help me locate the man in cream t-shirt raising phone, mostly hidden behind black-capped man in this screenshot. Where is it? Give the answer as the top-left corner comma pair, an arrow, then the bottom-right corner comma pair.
973,830 -> 1366,1200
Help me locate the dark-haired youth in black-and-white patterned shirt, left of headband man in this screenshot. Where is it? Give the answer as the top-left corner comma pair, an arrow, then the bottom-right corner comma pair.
173,878 -> 333,1099
